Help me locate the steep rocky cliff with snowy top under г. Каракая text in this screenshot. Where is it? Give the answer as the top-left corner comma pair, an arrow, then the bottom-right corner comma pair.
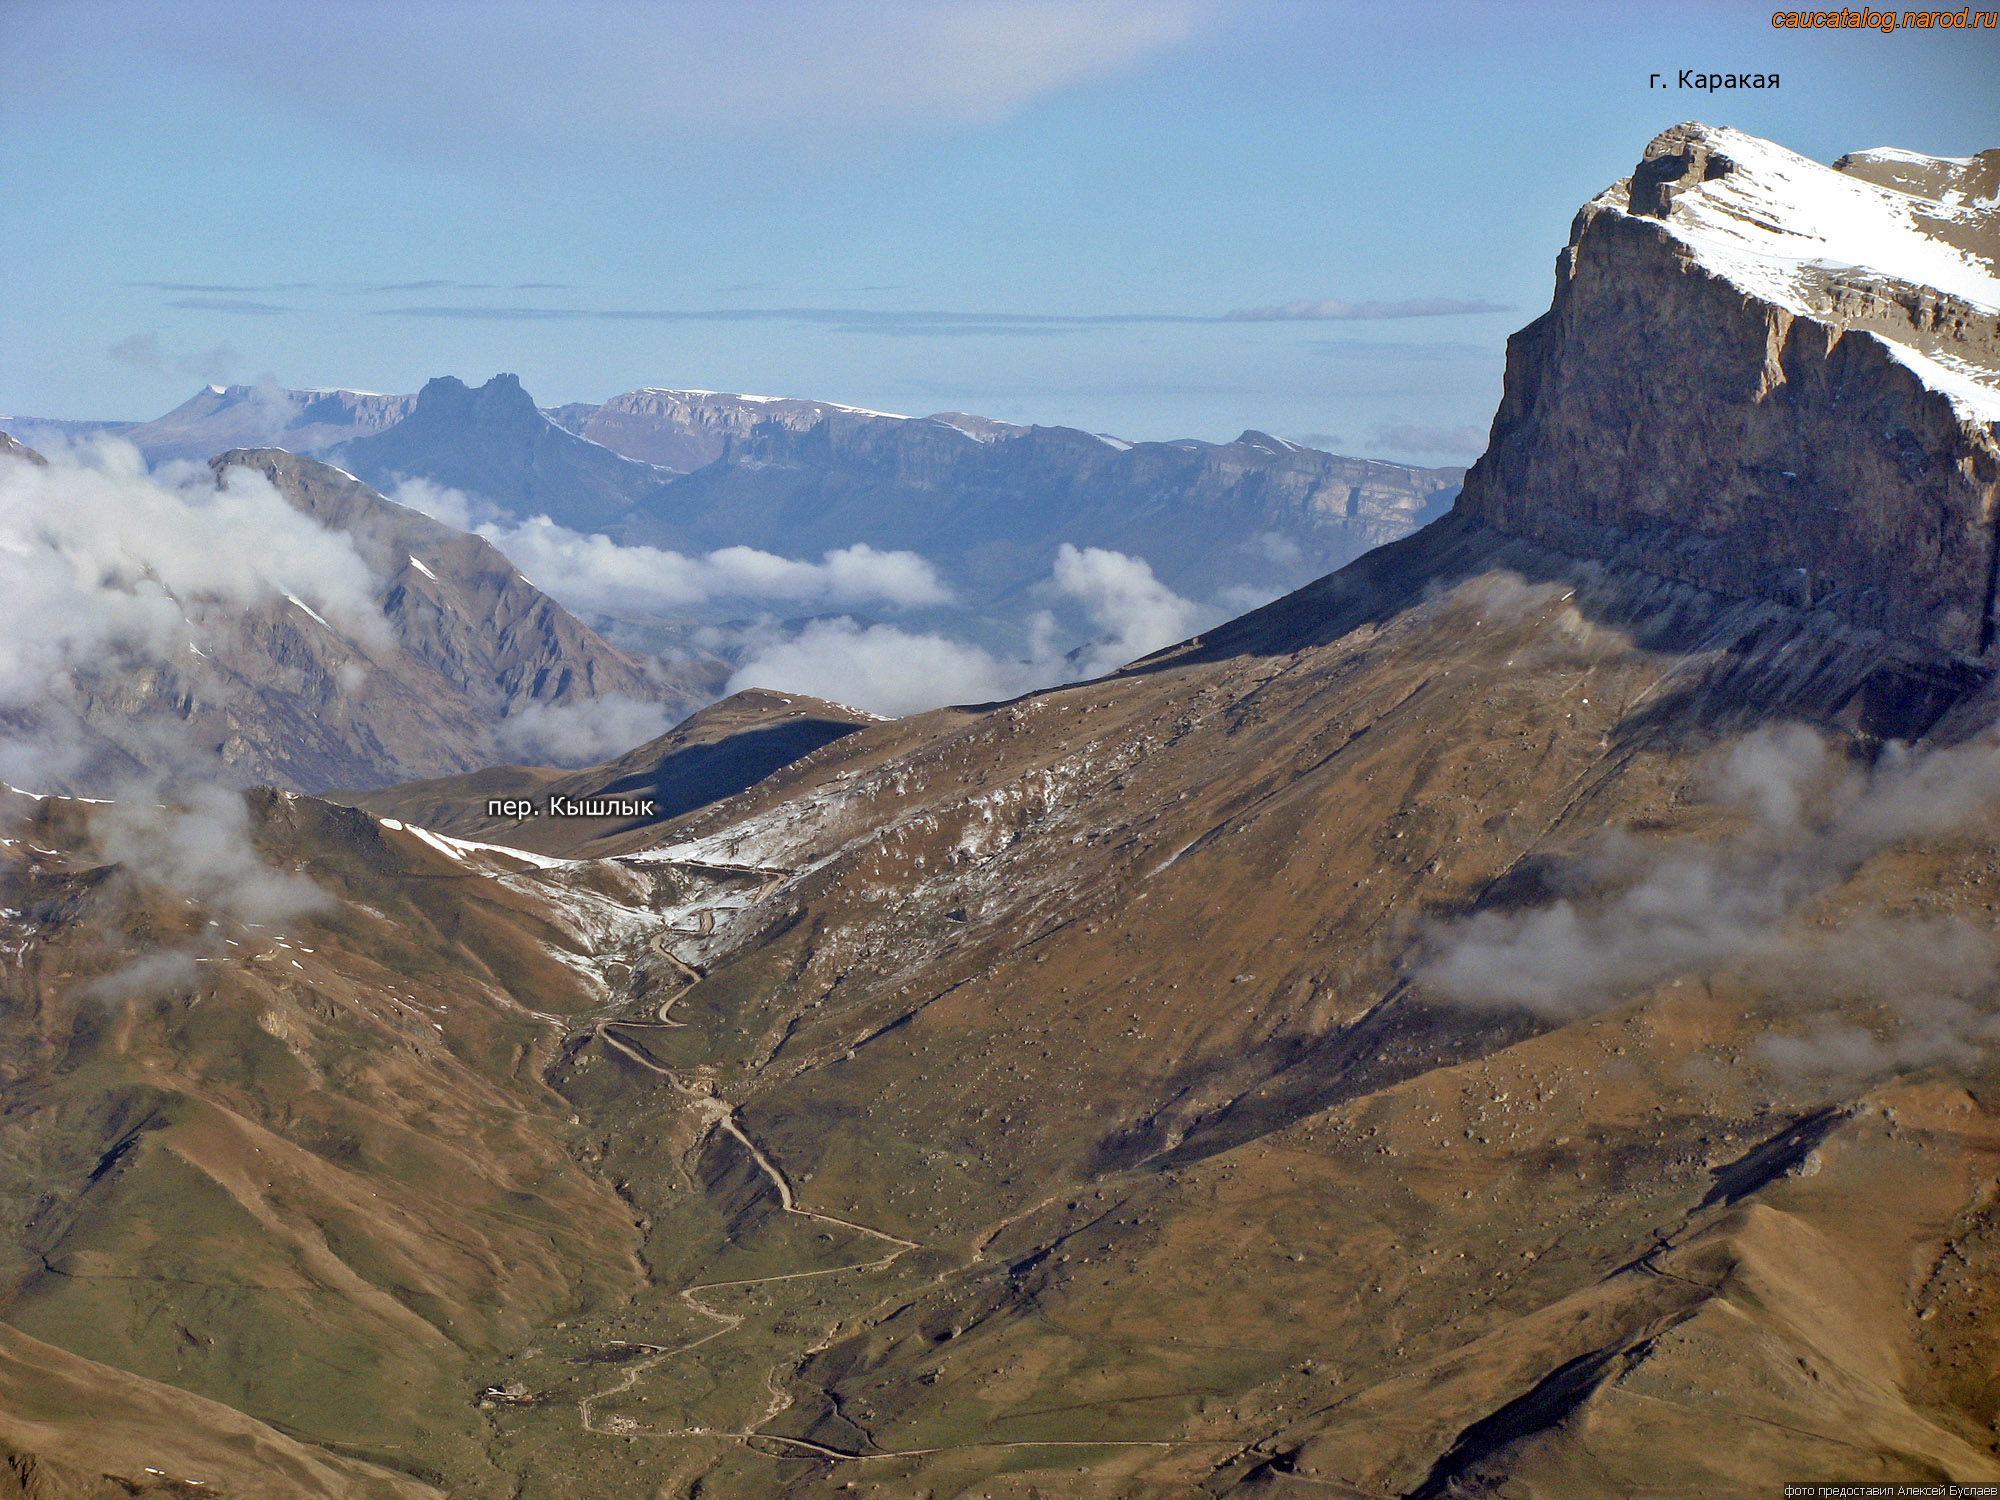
1460,124 -> 2000,656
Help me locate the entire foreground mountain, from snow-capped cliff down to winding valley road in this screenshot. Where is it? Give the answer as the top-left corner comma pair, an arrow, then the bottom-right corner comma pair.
0,126 -> 2000,1500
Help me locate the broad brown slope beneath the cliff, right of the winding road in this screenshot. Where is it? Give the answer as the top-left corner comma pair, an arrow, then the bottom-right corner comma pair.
522,524 -> 2000,1496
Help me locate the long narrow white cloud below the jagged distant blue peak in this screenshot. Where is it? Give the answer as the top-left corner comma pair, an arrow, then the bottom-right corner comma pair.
394,480 -> 952,614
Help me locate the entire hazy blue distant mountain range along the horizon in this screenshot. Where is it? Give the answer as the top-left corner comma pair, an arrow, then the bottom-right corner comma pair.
8,374 -> 1464,628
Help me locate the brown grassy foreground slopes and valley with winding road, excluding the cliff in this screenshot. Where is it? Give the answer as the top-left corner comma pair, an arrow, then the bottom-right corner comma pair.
0,520 -> 2000,1500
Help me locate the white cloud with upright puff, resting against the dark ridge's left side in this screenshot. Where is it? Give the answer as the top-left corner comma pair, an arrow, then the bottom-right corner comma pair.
712,542 -> 1216,718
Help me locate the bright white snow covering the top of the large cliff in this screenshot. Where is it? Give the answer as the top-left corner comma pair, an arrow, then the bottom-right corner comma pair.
1620,130 -> 2000,316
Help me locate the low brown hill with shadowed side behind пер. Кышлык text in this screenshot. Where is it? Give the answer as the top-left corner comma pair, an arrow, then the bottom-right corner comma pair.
330,688 -> 880,858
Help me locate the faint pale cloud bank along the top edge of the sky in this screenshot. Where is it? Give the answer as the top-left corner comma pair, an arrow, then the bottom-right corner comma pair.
43,0 -> 1230,162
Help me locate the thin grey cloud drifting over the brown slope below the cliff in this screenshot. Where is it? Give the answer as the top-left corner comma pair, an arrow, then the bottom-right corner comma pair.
1412,726 -> 2000,1066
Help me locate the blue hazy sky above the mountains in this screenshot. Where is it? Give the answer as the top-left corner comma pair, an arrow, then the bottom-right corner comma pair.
0,0 -> 2000,464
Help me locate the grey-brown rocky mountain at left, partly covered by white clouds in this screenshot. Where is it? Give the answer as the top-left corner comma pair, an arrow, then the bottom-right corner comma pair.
10,450 -> 726,790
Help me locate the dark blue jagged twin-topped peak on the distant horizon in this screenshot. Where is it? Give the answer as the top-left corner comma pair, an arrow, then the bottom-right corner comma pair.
328,374 -> 664,530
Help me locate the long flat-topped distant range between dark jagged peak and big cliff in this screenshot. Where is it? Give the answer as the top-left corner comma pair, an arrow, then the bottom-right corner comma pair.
556,390 -> 1462,602
